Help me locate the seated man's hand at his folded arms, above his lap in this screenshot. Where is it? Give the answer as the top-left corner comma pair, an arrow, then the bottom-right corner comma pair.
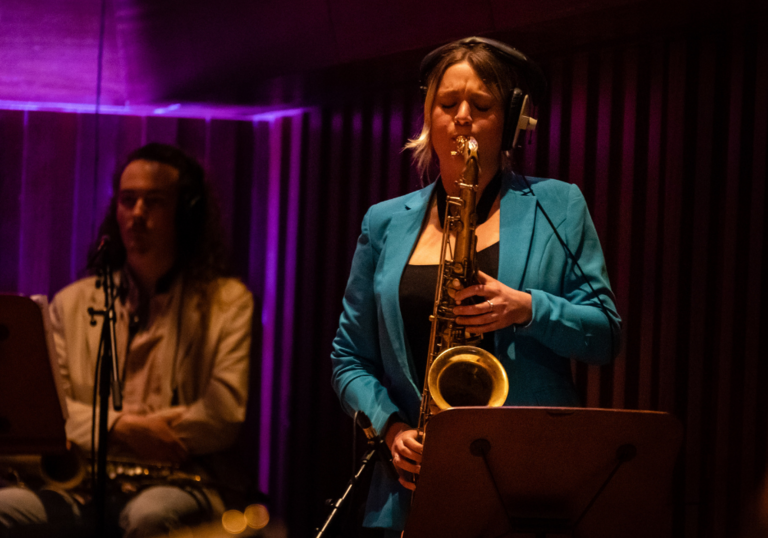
111,414 -> 188,463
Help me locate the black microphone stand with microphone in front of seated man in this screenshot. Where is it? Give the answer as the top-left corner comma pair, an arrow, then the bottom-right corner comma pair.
88,253 -> 123,537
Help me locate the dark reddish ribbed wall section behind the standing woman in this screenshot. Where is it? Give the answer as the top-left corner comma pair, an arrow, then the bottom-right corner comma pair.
286,23 -> 768,537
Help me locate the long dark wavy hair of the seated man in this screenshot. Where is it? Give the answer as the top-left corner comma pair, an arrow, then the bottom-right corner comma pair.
89,142 -> 231,282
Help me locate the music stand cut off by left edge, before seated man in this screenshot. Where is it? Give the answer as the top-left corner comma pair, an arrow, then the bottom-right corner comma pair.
0,295 -> 67,454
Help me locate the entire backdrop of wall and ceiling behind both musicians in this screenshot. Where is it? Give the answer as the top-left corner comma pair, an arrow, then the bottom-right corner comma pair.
0,0 -> 768,538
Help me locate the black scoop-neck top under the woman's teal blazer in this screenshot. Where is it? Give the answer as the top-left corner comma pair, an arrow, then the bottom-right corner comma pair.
400,243 -> 499,388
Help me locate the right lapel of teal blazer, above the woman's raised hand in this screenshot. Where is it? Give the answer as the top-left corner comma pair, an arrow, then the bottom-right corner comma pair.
499,175 -> 536,290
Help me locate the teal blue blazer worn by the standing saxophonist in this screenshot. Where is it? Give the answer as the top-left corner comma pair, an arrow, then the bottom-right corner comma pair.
331,173 -> 621,530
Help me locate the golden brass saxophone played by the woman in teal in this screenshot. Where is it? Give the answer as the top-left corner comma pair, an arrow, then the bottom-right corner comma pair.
418,136 -> 509,438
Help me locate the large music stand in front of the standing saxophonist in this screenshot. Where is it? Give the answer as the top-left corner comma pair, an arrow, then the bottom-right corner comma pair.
404,407 -> 682,538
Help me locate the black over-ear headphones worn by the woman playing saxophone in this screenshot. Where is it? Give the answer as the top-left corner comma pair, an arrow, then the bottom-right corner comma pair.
419,37 -> 547,151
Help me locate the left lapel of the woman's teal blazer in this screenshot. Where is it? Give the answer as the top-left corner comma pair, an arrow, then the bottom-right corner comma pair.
379,183 -> 434,384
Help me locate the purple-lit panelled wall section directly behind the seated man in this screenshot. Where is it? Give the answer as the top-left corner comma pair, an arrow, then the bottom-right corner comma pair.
0,110 -> 302,516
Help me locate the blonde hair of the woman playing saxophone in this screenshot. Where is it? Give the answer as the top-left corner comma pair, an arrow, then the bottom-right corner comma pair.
403,41 -> 518,179
